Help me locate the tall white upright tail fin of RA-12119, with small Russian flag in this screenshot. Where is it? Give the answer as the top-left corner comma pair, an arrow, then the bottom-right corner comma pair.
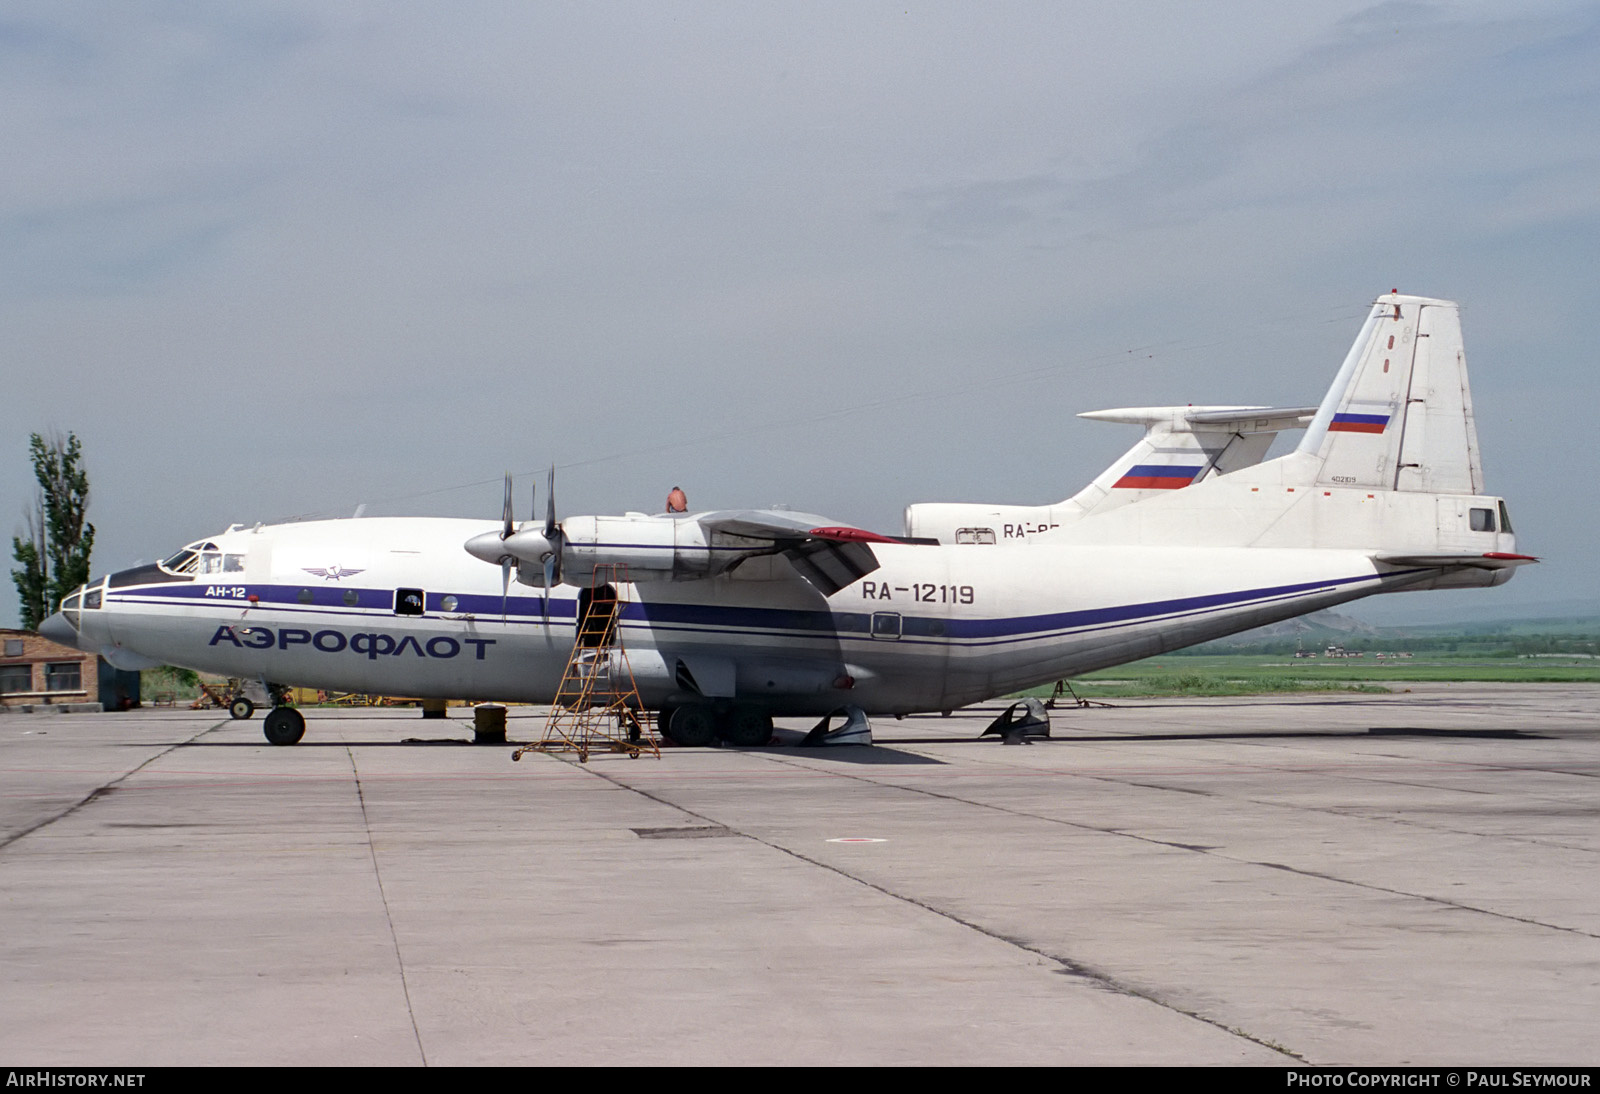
1296,293 -> 1483,494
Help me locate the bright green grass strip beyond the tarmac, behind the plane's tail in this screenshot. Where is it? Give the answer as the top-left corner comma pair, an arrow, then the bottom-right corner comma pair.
1026,654 -> 1600,697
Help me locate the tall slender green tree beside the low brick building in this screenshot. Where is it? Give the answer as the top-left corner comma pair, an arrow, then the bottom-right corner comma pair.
11,433 -> 94,630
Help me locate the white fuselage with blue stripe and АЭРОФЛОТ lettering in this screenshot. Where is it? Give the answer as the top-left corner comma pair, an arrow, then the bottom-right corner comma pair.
80,518 -> 1437,715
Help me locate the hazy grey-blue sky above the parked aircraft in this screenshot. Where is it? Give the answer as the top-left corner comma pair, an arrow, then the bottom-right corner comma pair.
0,0 -> 1600,625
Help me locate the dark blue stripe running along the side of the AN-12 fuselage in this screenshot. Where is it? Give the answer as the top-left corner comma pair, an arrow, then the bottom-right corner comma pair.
107,566 -> 1427,645
